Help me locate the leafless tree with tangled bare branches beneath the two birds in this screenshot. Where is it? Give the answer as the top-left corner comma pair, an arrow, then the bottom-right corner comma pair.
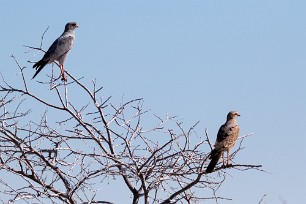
0,45 -> 261,204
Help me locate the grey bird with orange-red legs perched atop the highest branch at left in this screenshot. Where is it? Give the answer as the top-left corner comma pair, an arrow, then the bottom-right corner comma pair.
32,22 -> 78,81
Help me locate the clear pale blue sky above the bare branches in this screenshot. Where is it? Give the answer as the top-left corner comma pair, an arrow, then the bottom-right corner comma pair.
0,0 -> 306,204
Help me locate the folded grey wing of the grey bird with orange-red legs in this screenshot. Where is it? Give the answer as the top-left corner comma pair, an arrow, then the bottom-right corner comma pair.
43,35 -> 74,61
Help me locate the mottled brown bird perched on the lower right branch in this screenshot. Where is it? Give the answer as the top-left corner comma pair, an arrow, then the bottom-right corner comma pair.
206,111 -> 240,173
